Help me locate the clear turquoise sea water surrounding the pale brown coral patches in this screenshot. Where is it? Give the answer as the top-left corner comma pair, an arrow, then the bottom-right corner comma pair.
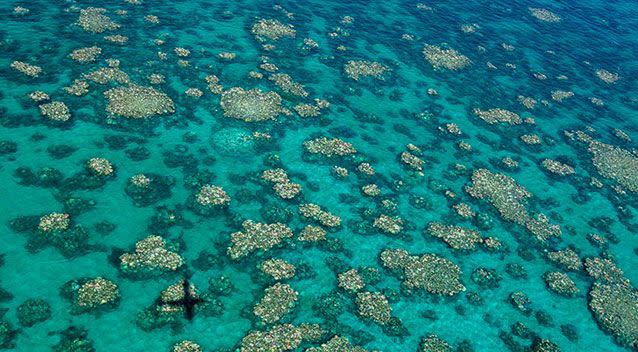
0,0 -> 638,351
